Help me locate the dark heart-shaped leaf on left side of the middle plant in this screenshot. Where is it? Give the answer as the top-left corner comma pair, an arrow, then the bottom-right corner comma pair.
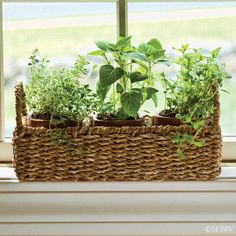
99,65 -> 124,87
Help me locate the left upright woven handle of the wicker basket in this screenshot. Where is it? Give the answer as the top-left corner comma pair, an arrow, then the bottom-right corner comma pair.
15,82 -> 27,129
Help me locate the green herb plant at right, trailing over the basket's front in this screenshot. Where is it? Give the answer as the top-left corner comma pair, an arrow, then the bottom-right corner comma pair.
160,45 -> 230,158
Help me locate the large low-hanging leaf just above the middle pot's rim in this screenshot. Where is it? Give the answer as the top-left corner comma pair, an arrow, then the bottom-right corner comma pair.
121,91 -> 143,117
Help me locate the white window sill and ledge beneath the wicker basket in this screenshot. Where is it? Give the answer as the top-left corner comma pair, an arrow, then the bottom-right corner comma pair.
0,167 -> 236,236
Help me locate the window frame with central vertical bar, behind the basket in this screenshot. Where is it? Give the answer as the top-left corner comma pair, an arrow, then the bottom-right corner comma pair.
0,0 -> 236,163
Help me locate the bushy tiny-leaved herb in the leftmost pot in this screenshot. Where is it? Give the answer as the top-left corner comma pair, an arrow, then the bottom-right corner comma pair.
26,49 -> 98,122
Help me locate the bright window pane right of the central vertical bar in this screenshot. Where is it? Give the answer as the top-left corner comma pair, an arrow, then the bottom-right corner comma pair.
128,2 -> 236,135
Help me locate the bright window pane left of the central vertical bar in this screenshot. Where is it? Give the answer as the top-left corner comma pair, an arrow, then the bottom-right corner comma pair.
3,2 -> 116,137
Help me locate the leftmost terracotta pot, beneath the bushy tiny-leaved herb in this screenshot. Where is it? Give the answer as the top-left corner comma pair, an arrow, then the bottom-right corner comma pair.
22,116 -> 78,129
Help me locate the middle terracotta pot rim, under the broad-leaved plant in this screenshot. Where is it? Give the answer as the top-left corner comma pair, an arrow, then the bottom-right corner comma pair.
93,118 -> 143,127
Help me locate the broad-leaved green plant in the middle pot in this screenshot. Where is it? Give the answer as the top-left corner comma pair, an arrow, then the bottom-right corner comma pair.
90,37 -> 165,119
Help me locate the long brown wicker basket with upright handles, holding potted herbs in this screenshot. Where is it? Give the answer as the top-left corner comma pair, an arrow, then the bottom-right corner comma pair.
13,84 -> 222,181
